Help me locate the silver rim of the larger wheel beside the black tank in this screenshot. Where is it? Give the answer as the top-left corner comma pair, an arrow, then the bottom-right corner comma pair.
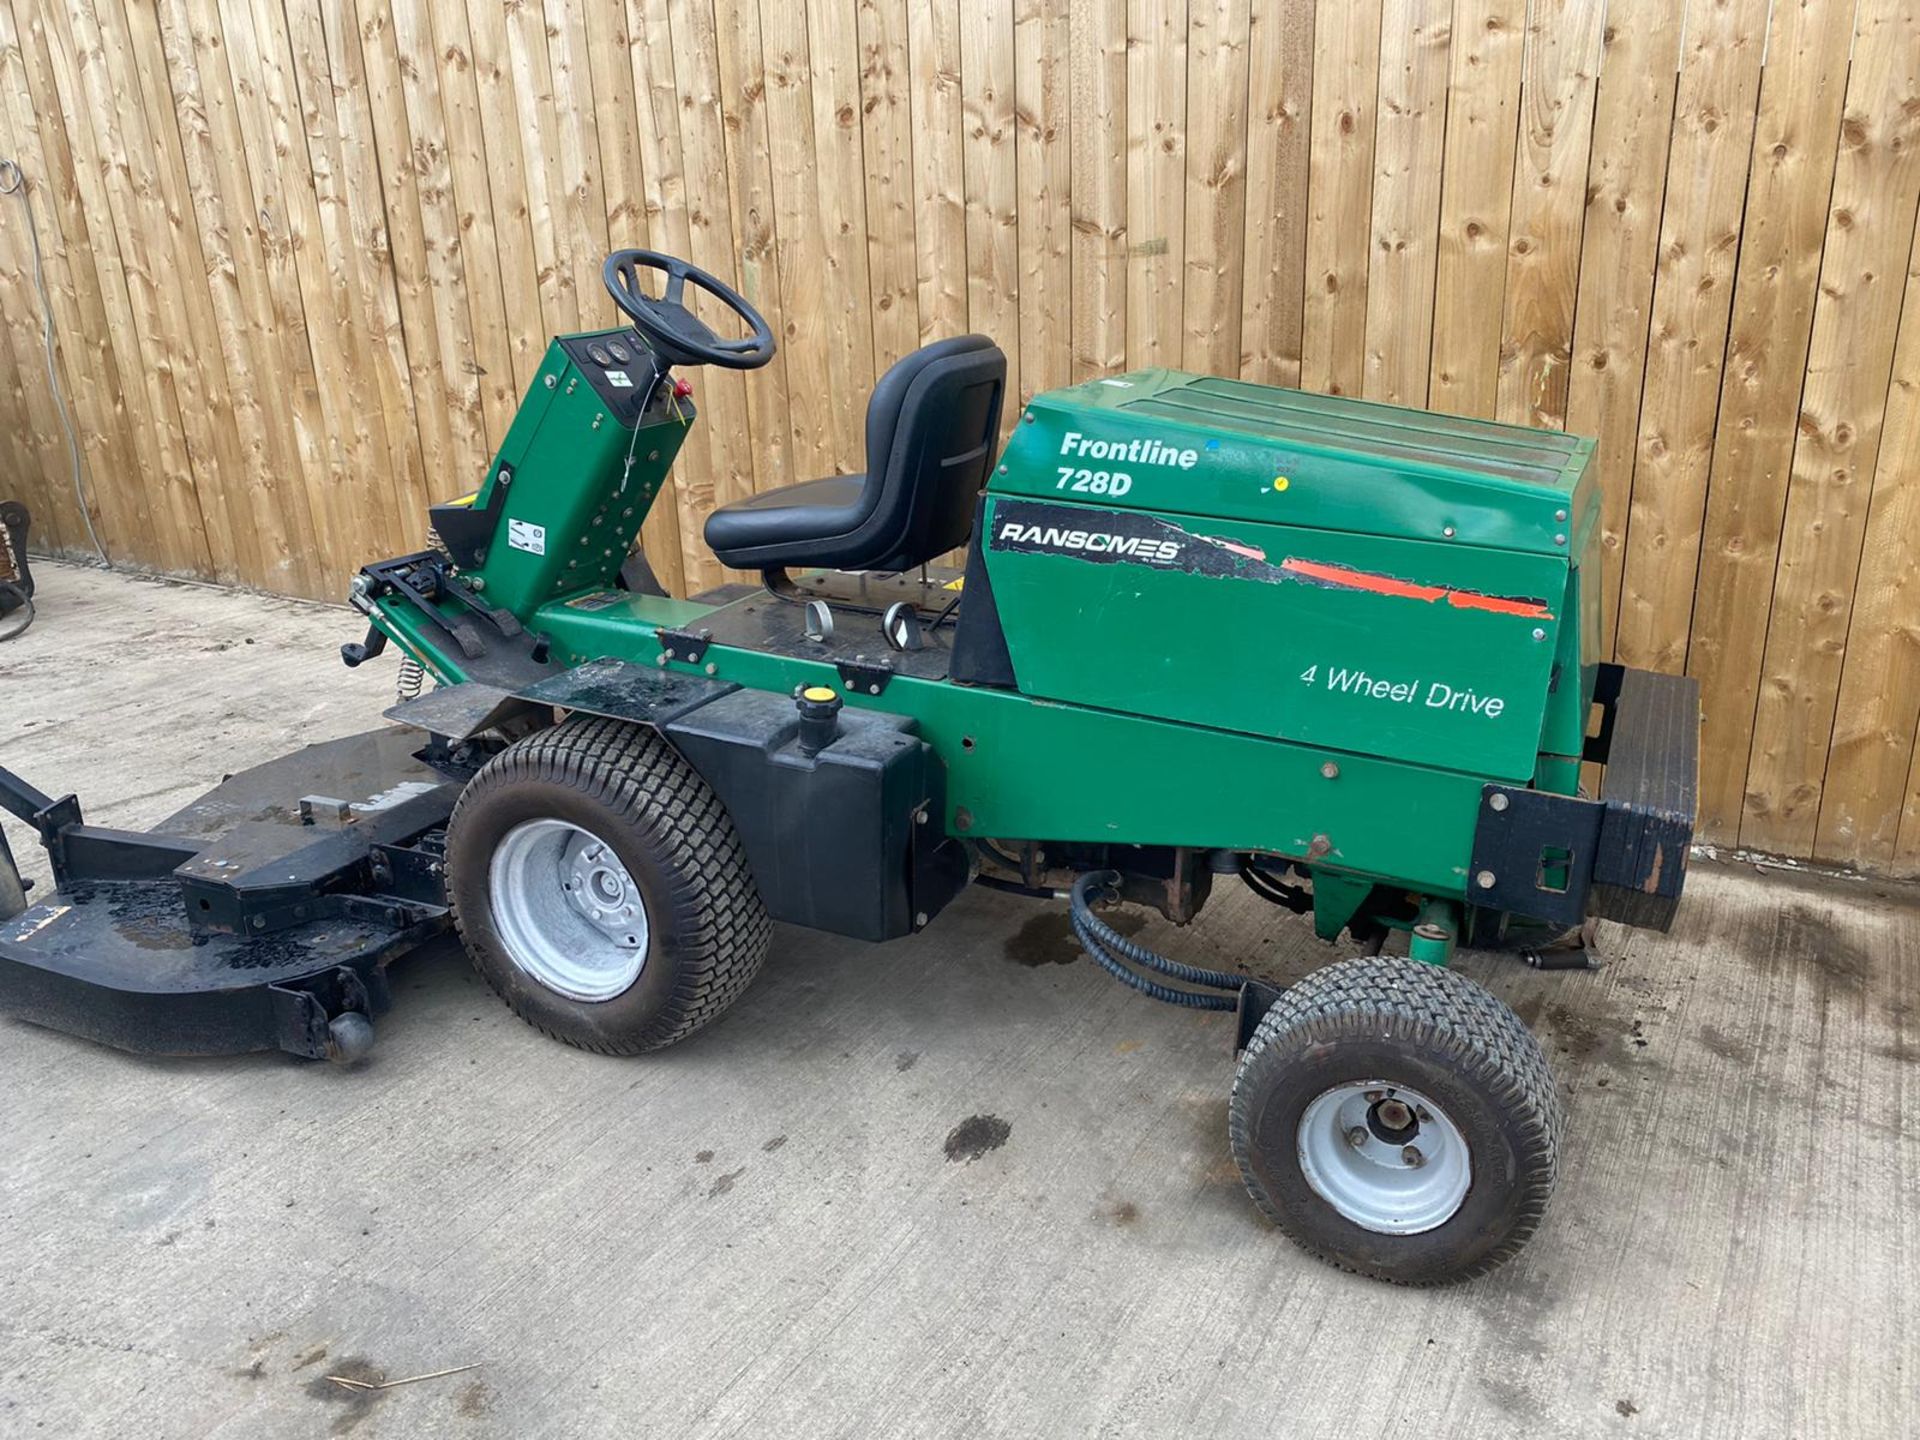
488,820 -> 647,1002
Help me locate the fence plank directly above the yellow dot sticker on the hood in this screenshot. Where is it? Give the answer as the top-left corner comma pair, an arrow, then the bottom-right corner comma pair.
1240,0 -> 1313,386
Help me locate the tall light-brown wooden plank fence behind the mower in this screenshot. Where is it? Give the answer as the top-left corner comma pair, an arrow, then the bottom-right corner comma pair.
0,0 -> 1920,872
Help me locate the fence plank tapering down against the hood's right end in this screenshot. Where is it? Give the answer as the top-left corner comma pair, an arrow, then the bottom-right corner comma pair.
1567,0 -> 1684,655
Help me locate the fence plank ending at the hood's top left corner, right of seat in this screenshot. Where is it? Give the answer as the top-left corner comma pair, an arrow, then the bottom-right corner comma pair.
1014,0 -> 1073,396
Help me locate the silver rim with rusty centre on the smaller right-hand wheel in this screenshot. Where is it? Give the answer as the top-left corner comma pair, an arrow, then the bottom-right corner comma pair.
1300,1081 -> 1473,1235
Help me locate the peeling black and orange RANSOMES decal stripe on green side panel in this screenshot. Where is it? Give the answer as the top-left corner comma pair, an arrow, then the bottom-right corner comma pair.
987,499 -> 1553,620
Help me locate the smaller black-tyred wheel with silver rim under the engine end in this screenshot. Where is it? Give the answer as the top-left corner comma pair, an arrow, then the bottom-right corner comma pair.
1227,956 -> 1561,1284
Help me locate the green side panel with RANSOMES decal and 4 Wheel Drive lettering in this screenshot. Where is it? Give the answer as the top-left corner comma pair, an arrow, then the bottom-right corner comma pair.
985,497 -> 1567,780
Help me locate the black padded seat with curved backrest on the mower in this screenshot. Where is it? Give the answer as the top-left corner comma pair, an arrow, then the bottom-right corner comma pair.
707,334 -> 1006,570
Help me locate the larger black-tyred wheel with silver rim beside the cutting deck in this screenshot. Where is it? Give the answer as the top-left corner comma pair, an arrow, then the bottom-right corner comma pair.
447,718 -> 772,1054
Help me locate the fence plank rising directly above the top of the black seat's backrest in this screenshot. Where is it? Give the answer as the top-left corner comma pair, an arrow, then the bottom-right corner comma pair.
906,0 -> 967,344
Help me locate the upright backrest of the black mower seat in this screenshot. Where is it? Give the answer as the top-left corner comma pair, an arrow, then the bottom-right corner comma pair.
860,334 -> 1006,570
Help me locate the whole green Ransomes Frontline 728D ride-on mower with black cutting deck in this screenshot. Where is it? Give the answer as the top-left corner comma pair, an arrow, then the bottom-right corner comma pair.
0,250 -> 1699,1283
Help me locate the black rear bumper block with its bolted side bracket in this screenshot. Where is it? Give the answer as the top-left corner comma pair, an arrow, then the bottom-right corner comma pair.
1469,664 -> 1699,929
